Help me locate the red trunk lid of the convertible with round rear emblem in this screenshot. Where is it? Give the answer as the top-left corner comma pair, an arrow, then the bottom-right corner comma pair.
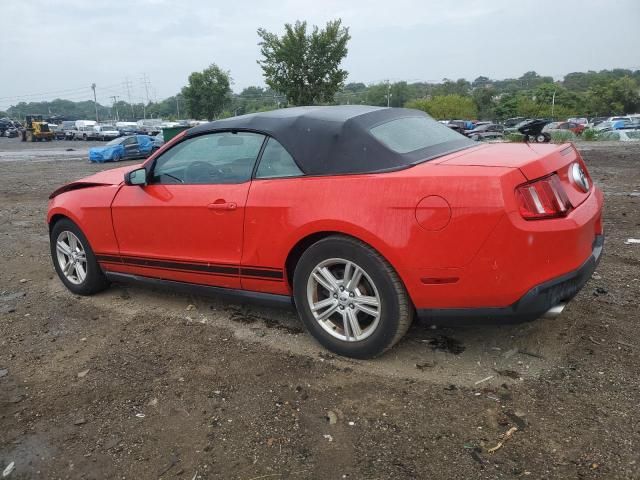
438,143 -> 593,207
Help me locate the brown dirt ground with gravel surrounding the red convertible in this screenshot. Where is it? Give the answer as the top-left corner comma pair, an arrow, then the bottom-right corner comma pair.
0,138 -> 640,480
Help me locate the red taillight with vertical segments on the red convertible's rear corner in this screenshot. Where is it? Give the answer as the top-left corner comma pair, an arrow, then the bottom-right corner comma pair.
516,173 -> 571,220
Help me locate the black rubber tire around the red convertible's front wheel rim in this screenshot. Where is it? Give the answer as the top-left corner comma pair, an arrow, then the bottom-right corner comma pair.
49,218 -> 109,295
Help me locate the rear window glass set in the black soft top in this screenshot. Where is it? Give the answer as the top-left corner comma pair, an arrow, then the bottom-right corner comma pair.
369,117 -> 464,153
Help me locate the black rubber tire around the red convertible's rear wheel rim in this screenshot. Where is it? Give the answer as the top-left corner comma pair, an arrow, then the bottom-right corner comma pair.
293,235 -> 414,358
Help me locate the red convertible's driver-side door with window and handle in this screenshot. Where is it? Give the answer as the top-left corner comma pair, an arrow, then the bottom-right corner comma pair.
108,132 -> 264,288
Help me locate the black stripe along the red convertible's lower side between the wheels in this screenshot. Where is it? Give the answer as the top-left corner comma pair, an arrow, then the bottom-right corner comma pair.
96,255 -> 284,280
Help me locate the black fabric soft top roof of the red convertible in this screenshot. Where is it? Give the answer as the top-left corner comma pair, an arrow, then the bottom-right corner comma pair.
186,105 -> 473,175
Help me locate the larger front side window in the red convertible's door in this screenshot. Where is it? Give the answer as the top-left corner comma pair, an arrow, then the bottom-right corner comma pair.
151,132 -> 264,184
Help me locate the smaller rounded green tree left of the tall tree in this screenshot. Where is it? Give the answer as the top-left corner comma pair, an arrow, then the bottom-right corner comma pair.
182,63 -> 231,120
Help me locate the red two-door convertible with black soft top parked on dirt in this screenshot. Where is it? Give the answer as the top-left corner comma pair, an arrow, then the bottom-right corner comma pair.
47,106 -> 604,358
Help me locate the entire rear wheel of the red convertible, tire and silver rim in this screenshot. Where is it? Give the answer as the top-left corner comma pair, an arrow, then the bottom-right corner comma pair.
293,236 -> 413,358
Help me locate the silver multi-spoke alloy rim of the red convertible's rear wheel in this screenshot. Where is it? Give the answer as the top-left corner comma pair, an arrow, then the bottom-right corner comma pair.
307,258 -> 382,342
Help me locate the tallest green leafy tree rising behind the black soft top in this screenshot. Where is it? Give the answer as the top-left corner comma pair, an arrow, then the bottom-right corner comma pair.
258,20 -> 351,105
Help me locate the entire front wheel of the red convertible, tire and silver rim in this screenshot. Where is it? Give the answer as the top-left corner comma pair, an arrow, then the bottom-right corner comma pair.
50,219 -> 109,295
